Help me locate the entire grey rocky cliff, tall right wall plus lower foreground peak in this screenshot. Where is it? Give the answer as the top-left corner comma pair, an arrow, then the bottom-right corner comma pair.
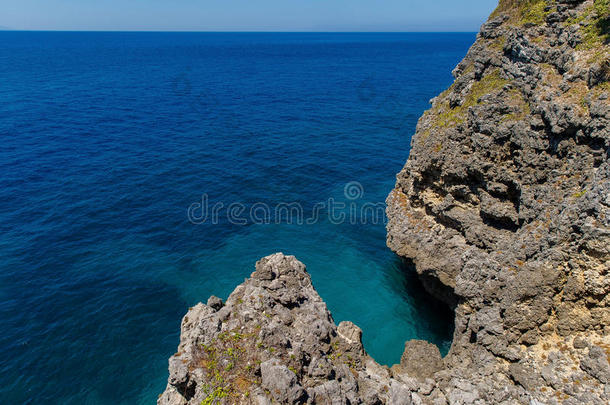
158,0 -> 610,405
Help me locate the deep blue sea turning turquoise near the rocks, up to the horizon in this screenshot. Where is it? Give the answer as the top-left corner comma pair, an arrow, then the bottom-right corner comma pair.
0,32 -> 475,405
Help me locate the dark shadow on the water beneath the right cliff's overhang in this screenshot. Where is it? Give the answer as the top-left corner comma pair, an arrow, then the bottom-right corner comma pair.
388,257 -> 455,356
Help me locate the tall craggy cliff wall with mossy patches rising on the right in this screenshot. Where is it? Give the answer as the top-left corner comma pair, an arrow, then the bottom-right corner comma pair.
387,0 -> 610,404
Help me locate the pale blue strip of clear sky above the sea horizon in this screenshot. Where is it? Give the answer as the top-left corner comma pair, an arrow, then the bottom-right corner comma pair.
0,0 -> 497,32
